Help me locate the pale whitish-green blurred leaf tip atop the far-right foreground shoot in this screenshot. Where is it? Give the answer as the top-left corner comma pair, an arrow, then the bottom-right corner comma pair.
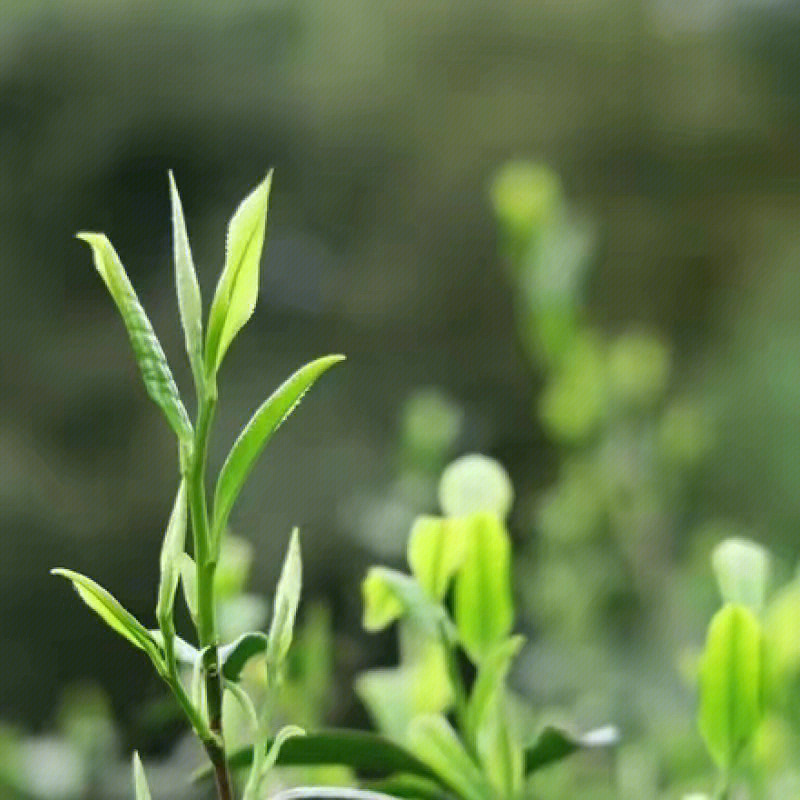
711,537 -> 771,614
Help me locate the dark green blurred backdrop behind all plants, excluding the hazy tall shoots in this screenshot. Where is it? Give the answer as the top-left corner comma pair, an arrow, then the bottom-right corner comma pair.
0,0 -> 800,784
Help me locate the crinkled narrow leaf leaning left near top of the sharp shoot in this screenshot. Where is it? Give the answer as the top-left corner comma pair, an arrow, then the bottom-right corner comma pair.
77,233 -> 192,443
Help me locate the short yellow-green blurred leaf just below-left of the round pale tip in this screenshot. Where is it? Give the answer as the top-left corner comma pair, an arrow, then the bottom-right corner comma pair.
408,517 -> 467,600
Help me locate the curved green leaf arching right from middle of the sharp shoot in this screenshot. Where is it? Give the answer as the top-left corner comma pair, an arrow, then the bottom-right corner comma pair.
214,355 -> 344,538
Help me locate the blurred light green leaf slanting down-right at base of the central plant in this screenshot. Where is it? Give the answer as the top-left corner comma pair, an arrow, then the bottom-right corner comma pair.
407,714 -> 493,800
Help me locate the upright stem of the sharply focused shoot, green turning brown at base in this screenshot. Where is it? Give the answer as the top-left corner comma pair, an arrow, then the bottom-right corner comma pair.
188,378 -> 233,800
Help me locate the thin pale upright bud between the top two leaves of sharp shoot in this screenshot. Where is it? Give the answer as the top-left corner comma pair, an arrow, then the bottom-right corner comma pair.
169,170 -> 204,386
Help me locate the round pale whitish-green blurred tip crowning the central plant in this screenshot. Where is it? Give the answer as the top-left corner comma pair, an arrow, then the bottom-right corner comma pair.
439,453 -> 514,519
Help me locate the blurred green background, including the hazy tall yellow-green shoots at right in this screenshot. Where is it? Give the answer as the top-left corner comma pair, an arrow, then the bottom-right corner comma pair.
0,0 -> 800,797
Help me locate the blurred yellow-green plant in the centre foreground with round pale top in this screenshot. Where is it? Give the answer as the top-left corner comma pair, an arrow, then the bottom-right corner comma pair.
357,455 -> 615,800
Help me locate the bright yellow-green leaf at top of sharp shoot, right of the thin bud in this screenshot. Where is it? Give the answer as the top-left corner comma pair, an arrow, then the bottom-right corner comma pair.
205,172 -> 272,373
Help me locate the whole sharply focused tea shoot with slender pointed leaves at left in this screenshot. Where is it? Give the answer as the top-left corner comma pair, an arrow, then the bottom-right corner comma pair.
54,174 -> 342,800
